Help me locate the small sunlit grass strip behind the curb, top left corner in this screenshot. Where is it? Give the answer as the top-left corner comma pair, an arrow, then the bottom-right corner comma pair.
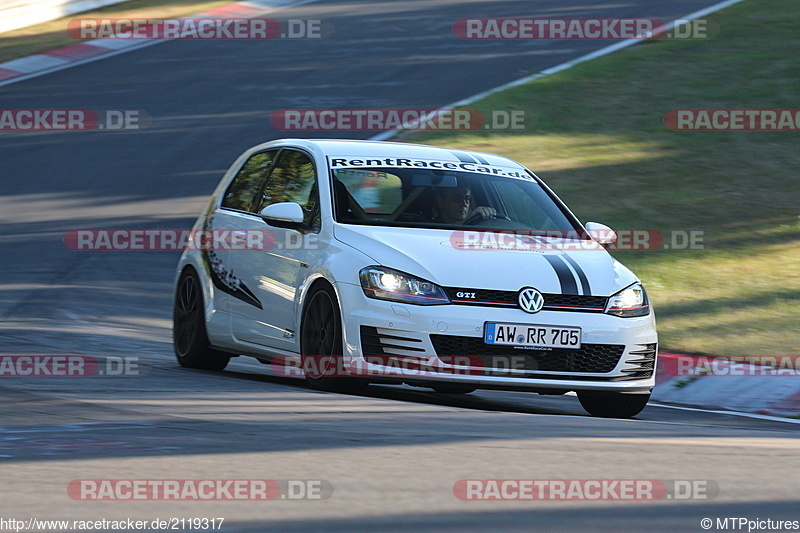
0,0 -> 231,63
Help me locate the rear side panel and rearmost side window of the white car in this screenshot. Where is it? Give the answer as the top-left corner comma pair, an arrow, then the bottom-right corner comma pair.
209,149 -> 279,335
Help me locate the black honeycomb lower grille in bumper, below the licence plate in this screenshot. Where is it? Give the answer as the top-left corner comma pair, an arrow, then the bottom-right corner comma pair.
431,335 -> 625,375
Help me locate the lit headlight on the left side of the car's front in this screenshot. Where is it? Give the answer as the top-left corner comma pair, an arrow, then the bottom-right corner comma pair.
358,266 -> 450,305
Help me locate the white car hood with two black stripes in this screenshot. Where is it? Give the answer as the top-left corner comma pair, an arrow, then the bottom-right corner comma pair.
334,224 -> 637,296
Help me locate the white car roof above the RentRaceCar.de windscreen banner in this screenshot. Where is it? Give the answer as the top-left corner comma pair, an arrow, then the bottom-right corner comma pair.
250,139 -> 525,169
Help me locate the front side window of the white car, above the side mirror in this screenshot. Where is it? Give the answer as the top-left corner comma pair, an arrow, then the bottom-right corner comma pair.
258,149 -> 320,228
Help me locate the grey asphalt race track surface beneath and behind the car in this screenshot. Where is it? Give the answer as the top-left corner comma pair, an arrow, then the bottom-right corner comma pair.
0,0 -> 800,532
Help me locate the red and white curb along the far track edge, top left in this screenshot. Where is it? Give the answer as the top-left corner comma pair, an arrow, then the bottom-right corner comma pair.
0,0 -> 317,86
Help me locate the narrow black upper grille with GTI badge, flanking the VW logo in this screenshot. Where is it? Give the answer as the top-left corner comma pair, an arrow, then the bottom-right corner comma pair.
444,287 -> 608,313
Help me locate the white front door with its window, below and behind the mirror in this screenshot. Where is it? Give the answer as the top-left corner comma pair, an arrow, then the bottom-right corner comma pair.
229,148 -> 320,351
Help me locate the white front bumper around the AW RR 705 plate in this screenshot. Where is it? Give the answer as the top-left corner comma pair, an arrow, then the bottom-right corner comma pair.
336,283 -> 658,393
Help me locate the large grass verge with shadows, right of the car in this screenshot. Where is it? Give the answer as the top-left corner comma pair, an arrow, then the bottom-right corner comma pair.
405,0 -> 800,355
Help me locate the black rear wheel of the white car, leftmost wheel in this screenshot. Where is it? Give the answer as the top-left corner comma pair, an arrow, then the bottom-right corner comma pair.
172,268 -> 230,370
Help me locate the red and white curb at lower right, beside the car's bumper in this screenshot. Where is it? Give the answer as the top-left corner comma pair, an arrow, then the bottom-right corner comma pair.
652,352 -> 800,416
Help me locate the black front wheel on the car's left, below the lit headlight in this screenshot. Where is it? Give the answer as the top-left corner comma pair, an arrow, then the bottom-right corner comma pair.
300,284 -> 369,394
